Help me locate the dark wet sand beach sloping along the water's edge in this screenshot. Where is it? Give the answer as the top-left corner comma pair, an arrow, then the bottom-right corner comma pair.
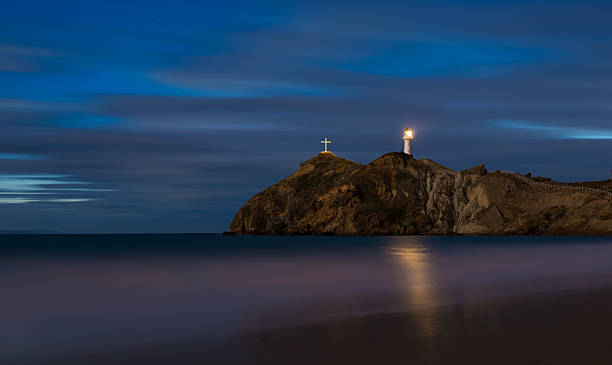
41,289 -> 612,365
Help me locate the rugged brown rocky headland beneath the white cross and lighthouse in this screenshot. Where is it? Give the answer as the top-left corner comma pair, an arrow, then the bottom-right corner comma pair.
230,152 -> 612,235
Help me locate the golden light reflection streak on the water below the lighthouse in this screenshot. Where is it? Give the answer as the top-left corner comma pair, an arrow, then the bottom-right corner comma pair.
387,240 -> 438,337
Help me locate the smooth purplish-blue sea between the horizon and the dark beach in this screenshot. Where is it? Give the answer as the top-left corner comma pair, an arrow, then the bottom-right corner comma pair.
0,235 -> 612,364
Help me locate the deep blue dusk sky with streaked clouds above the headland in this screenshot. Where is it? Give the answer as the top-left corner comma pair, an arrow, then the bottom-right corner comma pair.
0,0 -> 612,233
